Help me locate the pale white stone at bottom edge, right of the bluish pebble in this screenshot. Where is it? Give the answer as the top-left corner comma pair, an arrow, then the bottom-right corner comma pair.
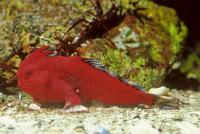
129,120 -> 159,134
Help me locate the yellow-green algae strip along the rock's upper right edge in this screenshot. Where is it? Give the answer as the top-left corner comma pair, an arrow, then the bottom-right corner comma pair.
134,0 -> 188,61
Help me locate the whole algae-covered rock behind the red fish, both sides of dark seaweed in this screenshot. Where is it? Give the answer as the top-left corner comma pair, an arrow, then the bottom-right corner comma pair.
0,0 -> 187,91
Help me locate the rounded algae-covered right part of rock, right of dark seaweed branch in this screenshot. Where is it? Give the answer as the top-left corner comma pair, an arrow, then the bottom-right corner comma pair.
78,0 -> 187,89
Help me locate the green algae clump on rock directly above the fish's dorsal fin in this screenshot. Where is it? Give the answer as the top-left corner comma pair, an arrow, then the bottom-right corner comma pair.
80,39 -> 166,89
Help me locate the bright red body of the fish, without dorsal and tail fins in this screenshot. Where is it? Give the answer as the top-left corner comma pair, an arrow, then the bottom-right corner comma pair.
17,46 -> 155,108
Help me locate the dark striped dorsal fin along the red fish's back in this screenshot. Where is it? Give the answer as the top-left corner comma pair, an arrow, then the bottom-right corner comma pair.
84,58 -> 144,90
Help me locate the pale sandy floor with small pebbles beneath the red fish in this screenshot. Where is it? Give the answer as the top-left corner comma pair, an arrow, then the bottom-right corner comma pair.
0,89 -> 200,134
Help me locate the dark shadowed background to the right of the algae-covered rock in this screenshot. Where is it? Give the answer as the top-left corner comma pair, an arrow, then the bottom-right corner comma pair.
154,0 -> 200,90
